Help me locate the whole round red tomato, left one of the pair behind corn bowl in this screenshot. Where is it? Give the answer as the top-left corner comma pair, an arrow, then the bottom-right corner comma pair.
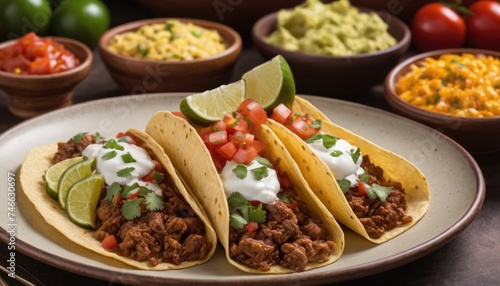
411,3 -> 466,52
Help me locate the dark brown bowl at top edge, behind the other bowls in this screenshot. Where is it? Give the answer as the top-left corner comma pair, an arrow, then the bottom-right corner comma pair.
137,0 -> 304,35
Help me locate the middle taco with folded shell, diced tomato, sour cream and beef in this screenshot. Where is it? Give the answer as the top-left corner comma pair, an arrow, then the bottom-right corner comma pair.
146,101 -> 344,274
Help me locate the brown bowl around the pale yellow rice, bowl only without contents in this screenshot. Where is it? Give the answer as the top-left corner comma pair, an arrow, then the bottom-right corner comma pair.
99,18 -> 242,94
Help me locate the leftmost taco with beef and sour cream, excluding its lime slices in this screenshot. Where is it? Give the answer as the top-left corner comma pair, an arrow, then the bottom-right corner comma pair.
20,129 -> 217,270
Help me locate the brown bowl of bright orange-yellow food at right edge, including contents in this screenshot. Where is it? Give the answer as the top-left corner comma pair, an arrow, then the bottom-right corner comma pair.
384,48 -> 500,153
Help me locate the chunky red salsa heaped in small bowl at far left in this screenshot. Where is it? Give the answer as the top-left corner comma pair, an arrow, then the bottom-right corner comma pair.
0,33 -> 80,74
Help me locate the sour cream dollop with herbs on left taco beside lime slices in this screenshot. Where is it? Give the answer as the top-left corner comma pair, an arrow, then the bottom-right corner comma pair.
82,141 -> 161,196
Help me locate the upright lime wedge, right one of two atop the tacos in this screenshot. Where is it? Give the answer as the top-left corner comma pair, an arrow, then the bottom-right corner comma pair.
243,55 -> 295,111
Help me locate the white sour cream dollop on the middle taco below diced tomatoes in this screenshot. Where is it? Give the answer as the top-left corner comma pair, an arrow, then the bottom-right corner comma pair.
220,159 -> 280,204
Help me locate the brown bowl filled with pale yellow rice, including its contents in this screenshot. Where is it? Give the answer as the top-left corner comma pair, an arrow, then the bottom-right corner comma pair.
99,18 -> 242,94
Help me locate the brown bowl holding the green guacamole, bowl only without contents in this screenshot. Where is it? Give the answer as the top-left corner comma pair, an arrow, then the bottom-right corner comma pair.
252,8 -> 411,98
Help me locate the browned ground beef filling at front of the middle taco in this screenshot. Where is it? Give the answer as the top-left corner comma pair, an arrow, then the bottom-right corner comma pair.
229,191 -> 335,272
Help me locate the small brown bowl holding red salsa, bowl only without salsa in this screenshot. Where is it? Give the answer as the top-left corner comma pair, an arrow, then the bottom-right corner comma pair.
0,37 -> 92,119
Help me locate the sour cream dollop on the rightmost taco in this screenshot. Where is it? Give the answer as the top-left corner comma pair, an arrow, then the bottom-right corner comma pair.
308,135 -> 365,186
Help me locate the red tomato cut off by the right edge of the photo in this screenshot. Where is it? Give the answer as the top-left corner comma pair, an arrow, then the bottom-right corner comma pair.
465,1 -> 500,51
